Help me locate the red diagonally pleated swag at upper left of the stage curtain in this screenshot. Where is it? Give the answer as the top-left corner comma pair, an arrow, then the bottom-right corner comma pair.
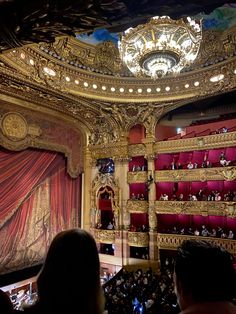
0,150 -> 62,227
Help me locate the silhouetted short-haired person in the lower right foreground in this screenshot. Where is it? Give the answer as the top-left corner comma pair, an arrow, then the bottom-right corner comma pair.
174,240 -> 236,314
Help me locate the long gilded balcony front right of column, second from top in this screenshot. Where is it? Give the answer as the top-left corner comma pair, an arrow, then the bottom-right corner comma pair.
155,166 -> 236,182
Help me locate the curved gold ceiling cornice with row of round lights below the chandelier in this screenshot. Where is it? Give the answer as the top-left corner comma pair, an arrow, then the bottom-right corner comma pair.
0,26 -> 236,103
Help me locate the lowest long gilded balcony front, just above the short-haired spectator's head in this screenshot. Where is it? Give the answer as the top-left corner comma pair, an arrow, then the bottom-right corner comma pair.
157,233 -> 236,255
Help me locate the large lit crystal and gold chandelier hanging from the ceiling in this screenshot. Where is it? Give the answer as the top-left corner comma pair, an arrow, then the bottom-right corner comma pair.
118,16 -> 202,79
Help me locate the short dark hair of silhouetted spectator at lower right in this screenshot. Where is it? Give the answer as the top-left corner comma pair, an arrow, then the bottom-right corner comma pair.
175,240 -> 236,302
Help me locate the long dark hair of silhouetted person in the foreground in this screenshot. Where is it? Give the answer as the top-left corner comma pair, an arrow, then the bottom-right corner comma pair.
37,229 -> 104,314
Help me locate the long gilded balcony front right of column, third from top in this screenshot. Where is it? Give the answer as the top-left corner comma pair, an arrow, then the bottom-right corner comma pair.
155,201 -> 236,218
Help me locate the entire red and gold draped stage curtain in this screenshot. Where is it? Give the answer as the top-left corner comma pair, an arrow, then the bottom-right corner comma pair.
0,150 -> 81,273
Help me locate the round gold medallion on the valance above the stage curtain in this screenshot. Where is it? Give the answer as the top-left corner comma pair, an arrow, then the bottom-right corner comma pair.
1,112 -> 28,141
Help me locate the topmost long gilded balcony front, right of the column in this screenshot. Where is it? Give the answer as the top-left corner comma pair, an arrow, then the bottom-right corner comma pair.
154,132 -> 236,154
